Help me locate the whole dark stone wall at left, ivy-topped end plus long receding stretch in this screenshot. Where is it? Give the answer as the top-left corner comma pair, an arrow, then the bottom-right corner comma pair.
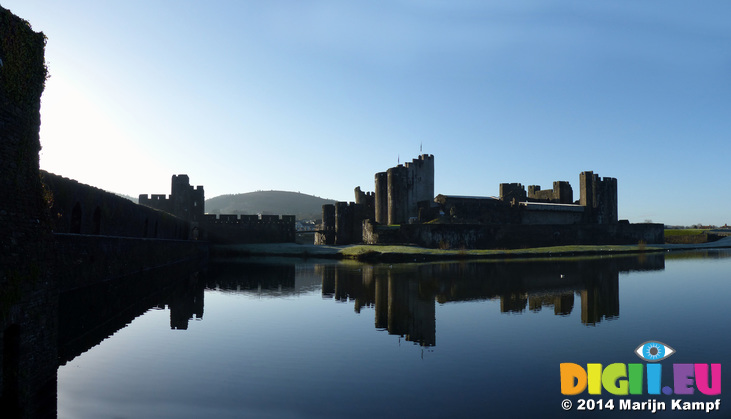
0,7 -> 212,418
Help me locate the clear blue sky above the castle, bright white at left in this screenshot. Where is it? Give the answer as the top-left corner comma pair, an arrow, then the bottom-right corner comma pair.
5,0 -> 731,225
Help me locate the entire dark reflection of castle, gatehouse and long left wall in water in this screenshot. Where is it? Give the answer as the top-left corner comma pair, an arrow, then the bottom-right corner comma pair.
51,251 -> 731,418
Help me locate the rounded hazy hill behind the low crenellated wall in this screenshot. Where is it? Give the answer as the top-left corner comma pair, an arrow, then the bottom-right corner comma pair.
206,191 -> 335,220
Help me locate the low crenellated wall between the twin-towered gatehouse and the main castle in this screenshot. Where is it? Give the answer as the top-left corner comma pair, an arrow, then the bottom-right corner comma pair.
201,214 -> 296,244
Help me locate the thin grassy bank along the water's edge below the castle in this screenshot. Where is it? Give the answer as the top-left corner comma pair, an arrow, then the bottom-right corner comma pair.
210,237 -> 731,263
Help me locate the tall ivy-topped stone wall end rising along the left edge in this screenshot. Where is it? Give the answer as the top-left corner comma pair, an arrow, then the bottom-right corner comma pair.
0,7 -> 58,417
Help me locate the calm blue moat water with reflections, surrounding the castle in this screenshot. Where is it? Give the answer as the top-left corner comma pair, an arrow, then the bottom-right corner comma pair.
58,251 -> 731,418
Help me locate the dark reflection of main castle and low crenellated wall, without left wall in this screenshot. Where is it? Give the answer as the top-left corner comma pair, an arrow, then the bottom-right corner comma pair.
207,254 -> 665,346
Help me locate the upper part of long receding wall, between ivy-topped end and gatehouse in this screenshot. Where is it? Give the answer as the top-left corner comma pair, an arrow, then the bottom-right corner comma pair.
42,172 -> 195,240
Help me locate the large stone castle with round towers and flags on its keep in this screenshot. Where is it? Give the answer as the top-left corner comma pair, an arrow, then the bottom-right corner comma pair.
315,154 -> 664,248
